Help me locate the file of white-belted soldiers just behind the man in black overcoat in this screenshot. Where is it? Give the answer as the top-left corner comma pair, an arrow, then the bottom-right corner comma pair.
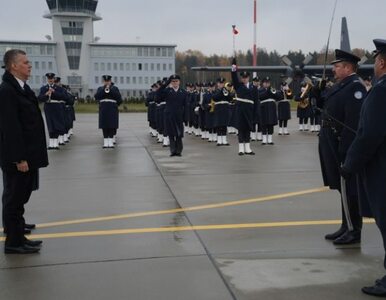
38,73 -> 75,150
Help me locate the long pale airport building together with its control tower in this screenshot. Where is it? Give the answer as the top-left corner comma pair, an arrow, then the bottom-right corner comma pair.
0,0 -> 176,98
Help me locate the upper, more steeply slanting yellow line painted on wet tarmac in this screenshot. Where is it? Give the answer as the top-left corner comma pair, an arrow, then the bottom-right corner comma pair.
32,187 -> 328,228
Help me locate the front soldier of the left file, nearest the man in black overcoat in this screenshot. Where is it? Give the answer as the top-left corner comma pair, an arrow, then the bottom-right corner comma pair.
38,73 -> 68,150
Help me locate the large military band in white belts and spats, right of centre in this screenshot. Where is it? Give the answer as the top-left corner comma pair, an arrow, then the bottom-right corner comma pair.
147,58 -> 320,155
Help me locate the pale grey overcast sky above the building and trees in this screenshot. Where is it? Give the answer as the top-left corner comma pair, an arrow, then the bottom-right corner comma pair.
0,0 -> 386,55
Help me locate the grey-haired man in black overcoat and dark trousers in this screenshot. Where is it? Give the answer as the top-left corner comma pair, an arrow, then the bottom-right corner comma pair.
0,49 -> 48,254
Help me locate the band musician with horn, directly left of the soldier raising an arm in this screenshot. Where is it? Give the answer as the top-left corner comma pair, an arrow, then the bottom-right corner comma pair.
212,77 -> 234,146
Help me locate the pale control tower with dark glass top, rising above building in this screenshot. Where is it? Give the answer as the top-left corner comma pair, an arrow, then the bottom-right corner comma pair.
44,0 -> 102,94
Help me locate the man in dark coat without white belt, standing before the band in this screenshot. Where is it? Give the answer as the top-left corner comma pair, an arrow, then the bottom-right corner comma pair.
161,75 -> 188,156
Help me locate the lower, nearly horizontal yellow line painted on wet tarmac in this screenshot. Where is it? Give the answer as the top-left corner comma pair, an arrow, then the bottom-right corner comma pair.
0,219 -> 375,242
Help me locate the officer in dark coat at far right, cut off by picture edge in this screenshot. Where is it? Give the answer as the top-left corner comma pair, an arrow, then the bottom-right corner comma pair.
341,39 -> 386,297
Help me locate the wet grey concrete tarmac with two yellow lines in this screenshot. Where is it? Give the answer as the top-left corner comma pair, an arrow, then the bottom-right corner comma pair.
0,113 -> 384,300
